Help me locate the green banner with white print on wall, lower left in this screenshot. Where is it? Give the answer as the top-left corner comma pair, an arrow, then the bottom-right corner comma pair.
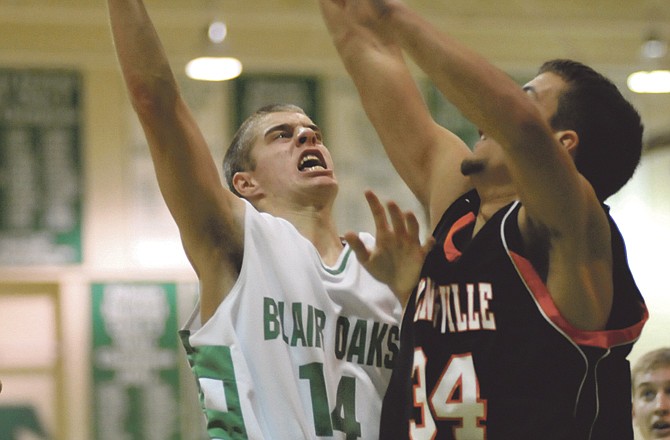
91,283 -> 181,440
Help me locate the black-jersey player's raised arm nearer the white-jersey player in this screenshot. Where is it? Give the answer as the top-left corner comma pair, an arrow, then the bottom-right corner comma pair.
319,0 -> 470,225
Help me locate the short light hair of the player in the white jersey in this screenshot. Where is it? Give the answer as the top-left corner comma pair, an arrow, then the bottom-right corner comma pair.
223,104 -> 306,197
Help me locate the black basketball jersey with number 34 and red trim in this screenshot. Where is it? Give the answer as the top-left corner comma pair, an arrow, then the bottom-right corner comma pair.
380,191 -> 647,440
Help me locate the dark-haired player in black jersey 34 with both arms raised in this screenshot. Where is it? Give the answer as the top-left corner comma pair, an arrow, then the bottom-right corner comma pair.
320,0 -> 647,440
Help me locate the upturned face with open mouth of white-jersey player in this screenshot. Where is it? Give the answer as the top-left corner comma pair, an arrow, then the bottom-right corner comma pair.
252,112 -> 337,202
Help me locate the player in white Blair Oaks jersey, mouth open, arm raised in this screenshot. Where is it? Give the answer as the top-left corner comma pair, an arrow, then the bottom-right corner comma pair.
108,0 -> 424,439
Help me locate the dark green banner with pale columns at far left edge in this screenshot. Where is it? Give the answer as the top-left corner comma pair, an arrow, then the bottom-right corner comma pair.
0,69 -> 82,265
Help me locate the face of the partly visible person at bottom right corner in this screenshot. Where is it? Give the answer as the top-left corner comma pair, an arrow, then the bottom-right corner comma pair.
633,367 -> 670,440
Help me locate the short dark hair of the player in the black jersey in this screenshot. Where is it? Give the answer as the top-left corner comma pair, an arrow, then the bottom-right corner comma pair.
538,59 -> 643,202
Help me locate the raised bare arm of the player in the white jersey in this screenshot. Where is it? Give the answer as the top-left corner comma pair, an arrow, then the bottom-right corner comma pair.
108,0 -> 244,317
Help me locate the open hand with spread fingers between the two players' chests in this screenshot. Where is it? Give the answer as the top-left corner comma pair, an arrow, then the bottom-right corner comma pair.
344,191 -> 435,305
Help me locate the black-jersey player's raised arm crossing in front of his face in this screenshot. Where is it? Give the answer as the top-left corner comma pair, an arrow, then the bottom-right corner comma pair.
370,0 -> 613,330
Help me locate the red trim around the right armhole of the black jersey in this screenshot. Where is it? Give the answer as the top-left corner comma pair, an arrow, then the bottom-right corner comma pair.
510,251 -> 649,348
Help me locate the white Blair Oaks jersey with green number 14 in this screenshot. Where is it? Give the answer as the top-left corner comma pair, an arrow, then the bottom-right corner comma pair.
182,203 -> 402,440
